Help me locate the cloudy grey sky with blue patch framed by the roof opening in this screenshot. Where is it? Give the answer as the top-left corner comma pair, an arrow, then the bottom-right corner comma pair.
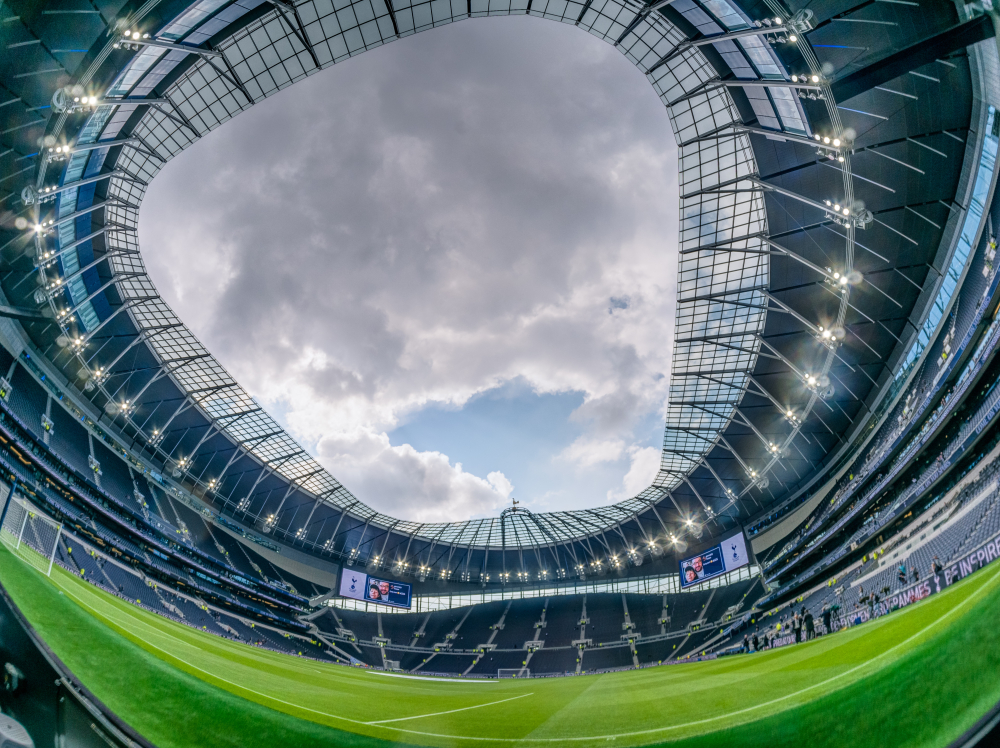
139,17 -> 678,522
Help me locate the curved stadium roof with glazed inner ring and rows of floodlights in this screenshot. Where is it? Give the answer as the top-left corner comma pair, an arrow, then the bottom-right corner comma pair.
0,0 -> 994,581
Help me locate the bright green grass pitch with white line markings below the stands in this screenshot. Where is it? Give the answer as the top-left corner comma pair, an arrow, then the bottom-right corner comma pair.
0,548 -> 1000,748
